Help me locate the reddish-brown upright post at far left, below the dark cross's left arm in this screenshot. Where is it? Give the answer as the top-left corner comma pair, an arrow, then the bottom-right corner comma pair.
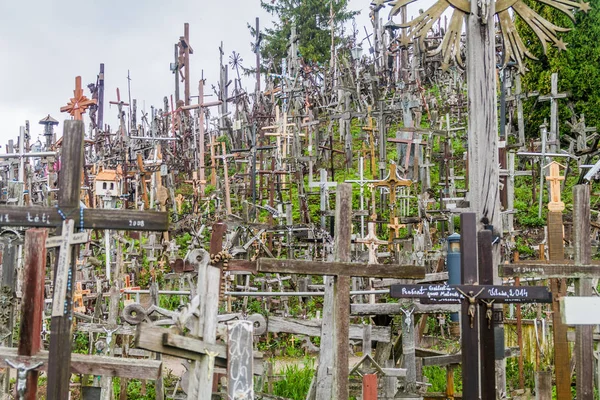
18,229 -> 48,400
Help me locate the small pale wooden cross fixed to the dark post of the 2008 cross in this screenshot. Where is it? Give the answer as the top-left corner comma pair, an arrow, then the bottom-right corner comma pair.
46,219 -> 90,317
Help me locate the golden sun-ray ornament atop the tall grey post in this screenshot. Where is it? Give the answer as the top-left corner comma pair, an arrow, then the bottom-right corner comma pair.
378,0 -> 590,72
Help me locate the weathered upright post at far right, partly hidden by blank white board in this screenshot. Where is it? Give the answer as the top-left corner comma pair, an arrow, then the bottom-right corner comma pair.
573,185 -> 594,400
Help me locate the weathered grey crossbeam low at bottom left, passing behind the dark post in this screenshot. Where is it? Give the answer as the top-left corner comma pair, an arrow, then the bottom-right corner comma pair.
0,347 -> 162,379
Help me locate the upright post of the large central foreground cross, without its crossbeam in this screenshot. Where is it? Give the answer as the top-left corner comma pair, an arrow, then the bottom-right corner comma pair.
332,183 -> 352,399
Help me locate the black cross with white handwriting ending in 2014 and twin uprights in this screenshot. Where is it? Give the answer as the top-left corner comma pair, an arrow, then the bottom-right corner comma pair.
390,213 -> 552,399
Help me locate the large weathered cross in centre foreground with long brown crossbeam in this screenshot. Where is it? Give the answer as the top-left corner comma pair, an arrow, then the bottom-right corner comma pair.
229,183 -> 425,400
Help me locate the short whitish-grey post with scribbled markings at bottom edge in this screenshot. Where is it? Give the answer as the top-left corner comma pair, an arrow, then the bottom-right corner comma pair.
227,321 -> 254,400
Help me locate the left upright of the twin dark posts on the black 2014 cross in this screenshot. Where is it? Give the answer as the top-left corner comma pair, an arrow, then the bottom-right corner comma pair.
460,213 -> 481,400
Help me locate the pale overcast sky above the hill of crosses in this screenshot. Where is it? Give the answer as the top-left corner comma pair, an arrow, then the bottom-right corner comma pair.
0,0 -> 422,148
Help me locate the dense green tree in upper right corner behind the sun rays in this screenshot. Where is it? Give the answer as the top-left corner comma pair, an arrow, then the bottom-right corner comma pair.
517,0 -> 600,137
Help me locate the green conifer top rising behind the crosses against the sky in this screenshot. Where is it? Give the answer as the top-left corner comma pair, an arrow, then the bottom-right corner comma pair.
255,0 -> 358,69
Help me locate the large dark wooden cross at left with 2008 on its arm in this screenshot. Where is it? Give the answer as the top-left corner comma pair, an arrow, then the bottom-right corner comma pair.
0,120 -> 168,400
